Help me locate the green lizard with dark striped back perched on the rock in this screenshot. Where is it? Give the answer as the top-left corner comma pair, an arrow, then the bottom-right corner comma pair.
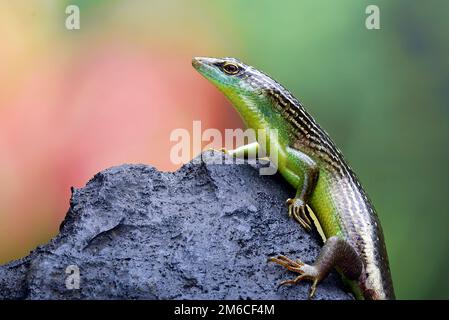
192,57 -> 395,299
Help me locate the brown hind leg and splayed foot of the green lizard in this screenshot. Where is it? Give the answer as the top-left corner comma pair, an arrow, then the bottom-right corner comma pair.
269,236 -> 363,299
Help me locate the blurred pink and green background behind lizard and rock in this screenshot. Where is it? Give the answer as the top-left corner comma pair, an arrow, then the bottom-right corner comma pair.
0,0 -> 449,299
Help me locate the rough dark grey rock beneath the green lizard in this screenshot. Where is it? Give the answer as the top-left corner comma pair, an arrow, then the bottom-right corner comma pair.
0,153 -> 352,299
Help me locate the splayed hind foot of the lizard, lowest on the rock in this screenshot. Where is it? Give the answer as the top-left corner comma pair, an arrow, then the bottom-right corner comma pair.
269,256 -> 320,299
